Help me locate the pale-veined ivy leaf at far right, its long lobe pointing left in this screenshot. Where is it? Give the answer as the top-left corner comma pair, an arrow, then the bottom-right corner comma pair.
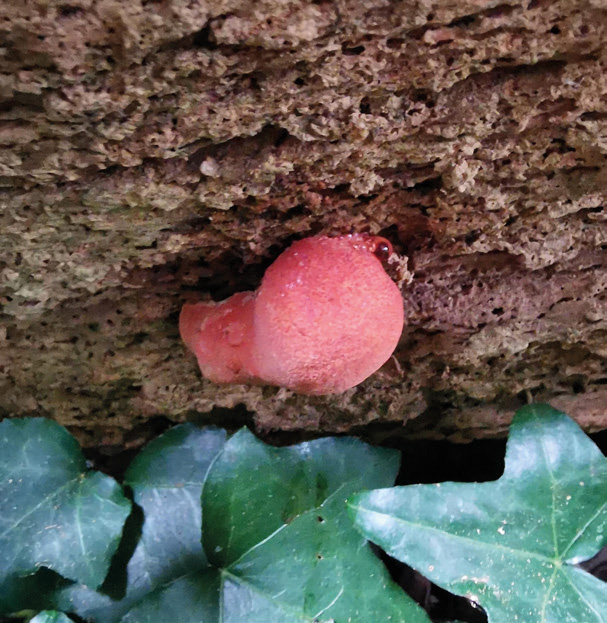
350,405 -> 607,623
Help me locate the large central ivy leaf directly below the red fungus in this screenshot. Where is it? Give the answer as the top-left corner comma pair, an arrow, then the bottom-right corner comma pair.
123,429 -> 429,623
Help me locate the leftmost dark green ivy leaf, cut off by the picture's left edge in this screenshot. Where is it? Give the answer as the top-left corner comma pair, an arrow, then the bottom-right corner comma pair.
0,418 -> 130,590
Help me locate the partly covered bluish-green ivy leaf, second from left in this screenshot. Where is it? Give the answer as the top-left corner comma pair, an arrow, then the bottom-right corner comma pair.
55,424 -> 227,623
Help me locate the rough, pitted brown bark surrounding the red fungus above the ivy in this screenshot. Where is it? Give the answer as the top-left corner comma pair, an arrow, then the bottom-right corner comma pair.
0,0 -> 607,443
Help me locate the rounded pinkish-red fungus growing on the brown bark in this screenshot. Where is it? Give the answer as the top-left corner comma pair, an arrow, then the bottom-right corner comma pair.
179,234 -> 404,395
